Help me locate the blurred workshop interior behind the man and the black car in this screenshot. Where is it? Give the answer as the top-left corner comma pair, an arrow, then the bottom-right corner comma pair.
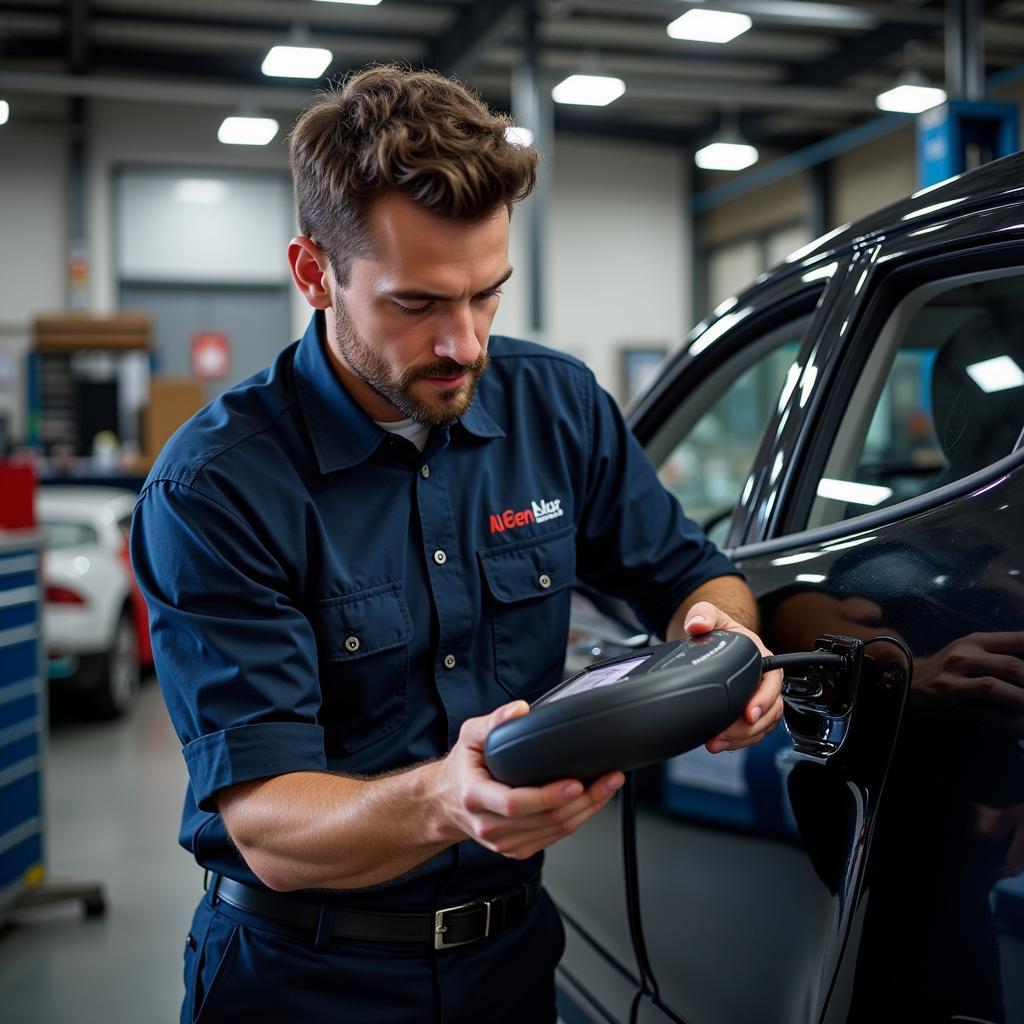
0,0 -> 1024,1024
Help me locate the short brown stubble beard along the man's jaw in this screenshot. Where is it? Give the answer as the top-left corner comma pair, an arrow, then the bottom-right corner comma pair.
334,302 -> 487,427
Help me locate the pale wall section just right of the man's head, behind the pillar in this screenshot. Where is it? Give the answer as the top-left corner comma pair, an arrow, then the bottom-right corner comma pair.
497,136 -> 690,397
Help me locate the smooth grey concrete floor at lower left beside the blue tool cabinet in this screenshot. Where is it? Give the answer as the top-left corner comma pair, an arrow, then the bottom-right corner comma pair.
0,678 -> 202,1024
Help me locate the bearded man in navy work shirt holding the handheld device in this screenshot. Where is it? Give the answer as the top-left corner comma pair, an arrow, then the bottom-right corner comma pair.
132,68 -> 781,1024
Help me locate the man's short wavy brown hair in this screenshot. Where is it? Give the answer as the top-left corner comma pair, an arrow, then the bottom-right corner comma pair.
289,65 -> 539,283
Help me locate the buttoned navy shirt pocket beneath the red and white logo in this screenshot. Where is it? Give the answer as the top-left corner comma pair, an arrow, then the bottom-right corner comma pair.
477,526 -> 575,700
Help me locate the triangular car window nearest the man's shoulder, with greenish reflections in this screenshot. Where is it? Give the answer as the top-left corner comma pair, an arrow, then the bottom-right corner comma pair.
647,312 -> 812,545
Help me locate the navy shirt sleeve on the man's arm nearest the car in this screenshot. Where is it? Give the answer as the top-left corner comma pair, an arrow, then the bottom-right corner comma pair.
577,375 -> 740,636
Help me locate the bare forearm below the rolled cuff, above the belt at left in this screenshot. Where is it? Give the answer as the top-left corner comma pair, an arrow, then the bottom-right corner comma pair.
218,763 -> 456,891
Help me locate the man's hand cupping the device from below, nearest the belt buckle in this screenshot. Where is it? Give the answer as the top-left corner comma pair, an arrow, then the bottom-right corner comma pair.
437,700 -> 626,860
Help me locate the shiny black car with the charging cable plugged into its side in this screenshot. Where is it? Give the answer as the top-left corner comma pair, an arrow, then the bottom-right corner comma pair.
546,149 -> 1024,1024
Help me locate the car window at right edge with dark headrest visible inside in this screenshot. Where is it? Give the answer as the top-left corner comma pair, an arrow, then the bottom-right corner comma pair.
806,270 -> 1024,527
